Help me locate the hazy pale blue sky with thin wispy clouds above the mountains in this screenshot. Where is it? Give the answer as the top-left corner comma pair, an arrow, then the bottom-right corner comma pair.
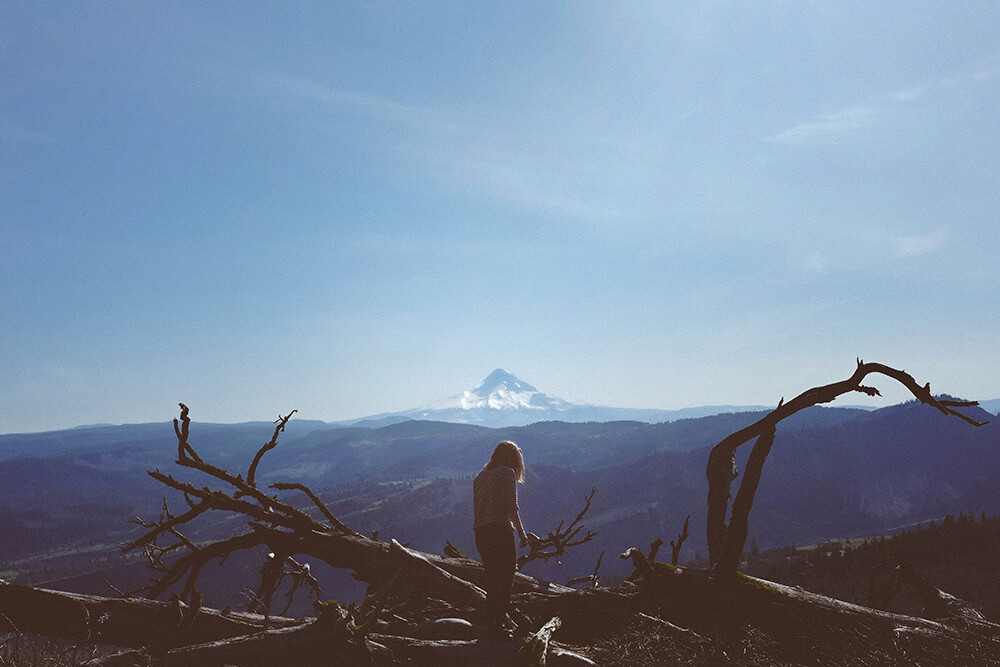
0,0 -> 1000,433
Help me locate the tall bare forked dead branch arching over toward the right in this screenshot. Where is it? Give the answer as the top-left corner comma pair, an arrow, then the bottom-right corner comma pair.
706,359 -> 983,576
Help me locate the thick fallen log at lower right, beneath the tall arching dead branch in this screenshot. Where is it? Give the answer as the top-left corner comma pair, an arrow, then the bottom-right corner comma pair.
624,563 -> 1000,664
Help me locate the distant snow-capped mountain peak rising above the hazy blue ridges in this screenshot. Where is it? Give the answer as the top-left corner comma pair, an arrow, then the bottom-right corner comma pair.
354,368 -> 764,428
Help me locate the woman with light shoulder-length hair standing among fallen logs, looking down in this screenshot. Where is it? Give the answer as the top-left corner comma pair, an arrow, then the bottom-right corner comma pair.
472,440 -> 538,634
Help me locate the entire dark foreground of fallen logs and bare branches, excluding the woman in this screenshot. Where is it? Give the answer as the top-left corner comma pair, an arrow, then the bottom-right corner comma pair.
0,360 -> 1000,667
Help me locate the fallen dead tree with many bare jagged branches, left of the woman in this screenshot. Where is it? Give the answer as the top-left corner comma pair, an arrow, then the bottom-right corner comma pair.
122,403 -> 593,613
